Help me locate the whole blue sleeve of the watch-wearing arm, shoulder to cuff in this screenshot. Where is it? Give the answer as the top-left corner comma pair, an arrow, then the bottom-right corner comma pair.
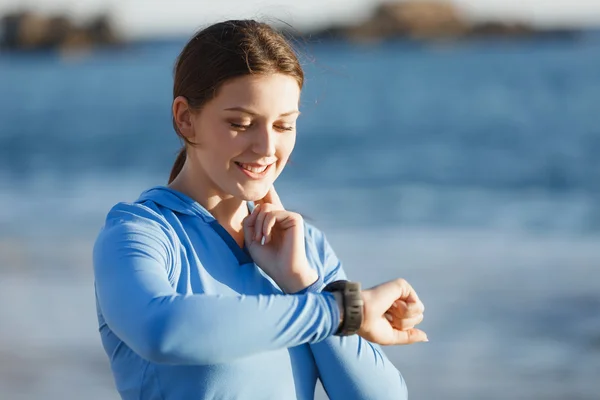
93,208 -> 339,365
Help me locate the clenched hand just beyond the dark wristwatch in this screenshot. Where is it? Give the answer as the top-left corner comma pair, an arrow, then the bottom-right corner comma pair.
358,279 -> 429,345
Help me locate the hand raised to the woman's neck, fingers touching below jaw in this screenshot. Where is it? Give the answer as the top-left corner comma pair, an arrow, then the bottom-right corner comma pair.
243,187 -> 318,293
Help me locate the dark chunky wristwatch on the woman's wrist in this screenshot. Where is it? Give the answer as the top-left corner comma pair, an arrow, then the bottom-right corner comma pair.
323,280 -> 364,336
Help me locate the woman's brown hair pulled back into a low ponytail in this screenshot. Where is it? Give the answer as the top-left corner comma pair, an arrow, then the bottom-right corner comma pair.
169,20 -> 304,183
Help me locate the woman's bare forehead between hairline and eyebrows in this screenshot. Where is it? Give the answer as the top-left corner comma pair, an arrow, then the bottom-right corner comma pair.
213,74 -> 300,114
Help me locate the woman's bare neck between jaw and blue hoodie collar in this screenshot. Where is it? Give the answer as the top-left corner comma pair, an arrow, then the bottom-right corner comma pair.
169,162 -> 248,234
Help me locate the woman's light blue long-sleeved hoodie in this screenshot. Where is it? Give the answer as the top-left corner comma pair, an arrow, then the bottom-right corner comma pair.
93,186 -> 407,400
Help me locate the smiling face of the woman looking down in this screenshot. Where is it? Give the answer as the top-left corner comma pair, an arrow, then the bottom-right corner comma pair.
180,74 -> 300,201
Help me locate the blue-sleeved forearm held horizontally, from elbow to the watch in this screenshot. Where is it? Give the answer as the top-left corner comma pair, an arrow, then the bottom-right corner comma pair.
101,288 -> 339,365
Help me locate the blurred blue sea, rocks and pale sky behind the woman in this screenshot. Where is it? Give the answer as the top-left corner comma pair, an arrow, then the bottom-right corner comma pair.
0,0 -> 600,400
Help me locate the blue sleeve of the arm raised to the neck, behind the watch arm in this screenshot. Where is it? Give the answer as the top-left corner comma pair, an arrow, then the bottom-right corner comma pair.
310,228 -> 408,400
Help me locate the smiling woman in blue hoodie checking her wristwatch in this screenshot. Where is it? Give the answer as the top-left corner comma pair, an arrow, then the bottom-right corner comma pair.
94,21 -> 427,400
